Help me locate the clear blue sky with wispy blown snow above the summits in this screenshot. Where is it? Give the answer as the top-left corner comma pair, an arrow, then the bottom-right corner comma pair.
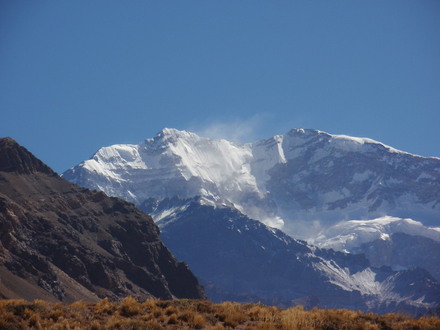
0,0 -> 440,172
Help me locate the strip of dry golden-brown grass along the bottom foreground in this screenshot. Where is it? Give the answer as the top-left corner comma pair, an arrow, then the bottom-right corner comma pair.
0,297 -> 440,330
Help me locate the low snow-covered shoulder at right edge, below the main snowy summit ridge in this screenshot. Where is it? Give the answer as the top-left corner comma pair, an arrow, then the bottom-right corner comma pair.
312,217 -> 440,280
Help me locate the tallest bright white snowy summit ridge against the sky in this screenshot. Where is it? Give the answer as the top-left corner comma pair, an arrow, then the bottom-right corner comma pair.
63,129 -> 440,239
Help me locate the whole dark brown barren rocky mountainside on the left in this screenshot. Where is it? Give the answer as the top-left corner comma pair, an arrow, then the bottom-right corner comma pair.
0,138 -> 203,302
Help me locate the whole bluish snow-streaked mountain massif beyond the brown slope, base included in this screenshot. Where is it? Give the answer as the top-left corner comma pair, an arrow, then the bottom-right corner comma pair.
63,129 -> 440,312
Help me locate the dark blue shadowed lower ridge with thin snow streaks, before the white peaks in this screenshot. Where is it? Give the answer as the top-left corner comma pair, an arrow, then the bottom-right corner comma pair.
142,197 -> 440,314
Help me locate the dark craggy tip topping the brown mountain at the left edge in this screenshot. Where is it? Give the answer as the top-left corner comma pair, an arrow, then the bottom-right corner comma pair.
0,137 -> 56,175
